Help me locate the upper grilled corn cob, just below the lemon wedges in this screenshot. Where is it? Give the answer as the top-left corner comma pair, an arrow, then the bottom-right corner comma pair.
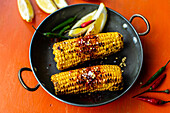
53,32 -> 123,70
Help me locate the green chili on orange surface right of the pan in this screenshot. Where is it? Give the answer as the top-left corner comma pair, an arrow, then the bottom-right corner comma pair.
141,60 -> 170,88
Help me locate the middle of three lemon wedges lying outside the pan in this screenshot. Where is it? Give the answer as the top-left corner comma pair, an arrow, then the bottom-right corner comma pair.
35,0 -> 58,14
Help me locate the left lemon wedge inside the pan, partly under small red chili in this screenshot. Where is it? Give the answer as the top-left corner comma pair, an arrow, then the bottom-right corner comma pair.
68,10 -> 97,37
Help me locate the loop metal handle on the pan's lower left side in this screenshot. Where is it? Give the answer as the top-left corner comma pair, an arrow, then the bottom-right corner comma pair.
18,67 -> 40,91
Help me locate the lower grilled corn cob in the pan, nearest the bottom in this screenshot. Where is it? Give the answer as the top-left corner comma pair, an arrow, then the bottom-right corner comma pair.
51,65 -> 123,95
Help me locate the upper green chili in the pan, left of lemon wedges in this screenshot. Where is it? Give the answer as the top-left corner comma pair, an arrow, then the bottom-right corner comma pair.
52,16 -> 77,32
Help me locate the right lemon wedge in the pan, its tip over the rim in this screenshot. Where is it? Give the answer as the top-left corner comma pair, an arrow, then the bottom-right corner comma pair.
85,3 -> 107,35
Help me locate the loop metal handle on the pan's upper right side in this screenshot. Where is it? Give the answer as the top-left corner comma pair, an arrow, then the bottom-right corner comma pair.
129,14 -> 150,36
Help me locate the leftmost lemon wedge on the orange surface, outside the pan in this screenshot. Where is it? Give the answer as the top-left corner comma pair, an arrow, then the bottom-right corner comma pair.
17,0 -> 34,22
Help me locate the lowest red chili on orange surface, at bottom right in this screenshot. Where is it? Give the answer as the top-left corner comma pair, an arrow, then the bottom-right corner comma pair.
137,96 -> 170,105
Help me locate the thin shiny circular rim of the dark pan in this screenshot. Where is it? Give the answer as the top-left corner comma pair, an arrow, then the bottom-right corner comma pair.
29,3 -> 143,107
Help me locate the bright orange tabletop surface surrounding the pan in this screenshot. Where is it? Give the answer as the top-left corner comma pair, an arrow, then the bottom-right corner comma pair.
0,0 -> 170,113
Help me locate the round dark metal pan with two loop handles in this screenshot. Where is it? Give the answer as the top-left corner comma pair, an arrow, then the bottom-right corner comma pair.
18,4 -> 150,107
